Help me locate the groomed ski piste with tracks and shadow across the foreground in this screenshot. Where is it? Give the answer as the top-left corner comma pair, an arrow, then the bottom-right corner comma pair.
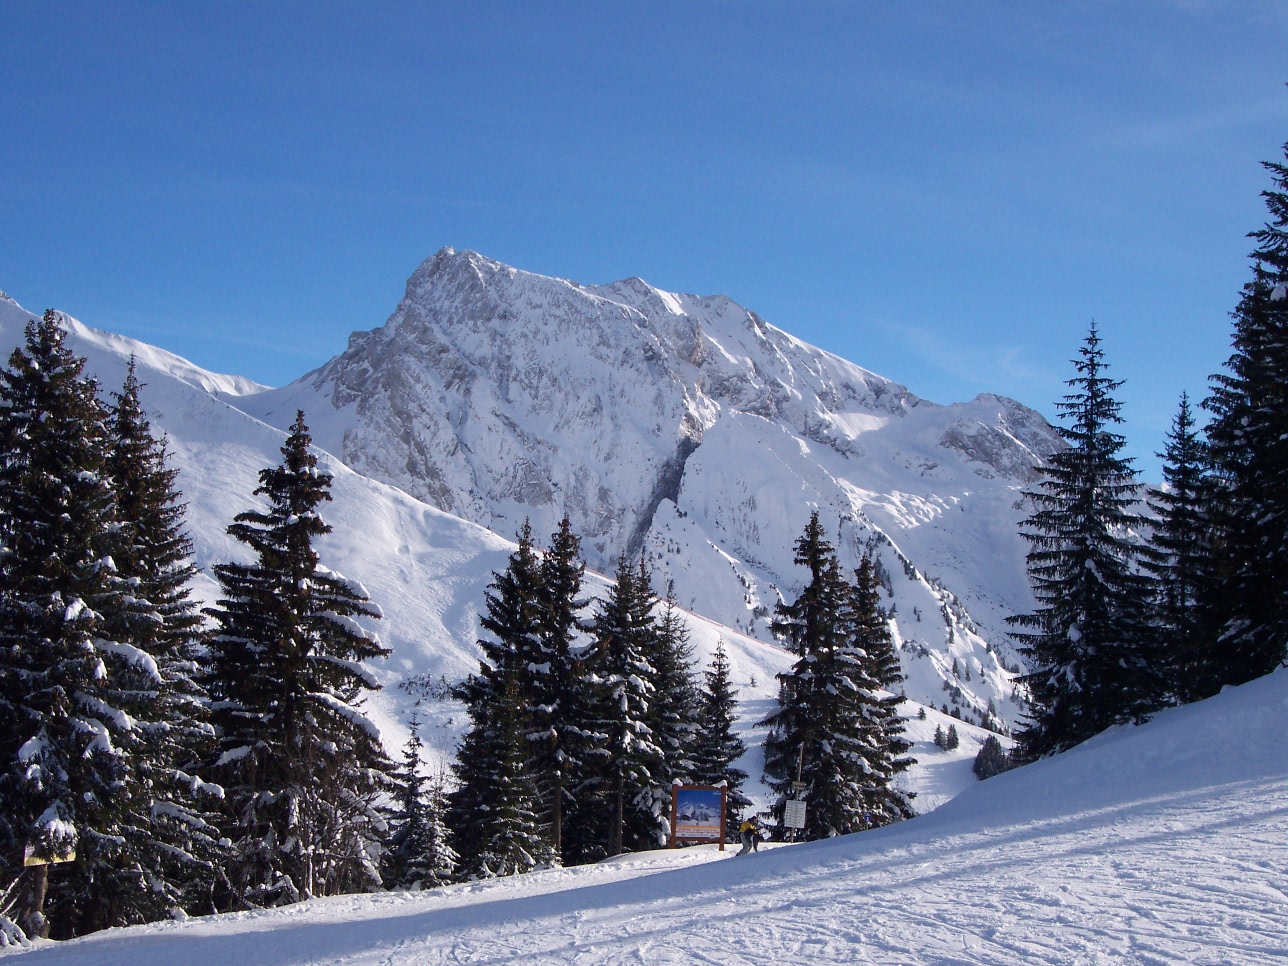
8,671 -> 1288,966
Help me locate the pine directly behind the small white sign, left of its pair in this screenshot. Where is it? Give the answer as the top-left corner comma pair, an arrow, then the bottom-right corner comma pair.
760,513 -> 878,838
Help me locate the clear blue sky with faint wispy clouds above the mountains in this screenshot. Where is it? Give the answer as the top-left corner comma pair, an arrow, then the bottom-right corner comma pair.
0,0 -> 1288,478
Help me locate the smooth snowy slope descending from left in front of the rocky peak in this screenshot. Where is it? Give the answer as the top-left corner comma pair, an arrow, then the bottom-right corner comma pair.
0,296 -> 788,774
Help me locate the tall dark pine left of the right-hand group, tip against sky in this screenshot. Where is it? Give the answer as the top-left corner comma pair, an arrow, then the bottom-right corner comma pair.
1007,323 -> 1163,761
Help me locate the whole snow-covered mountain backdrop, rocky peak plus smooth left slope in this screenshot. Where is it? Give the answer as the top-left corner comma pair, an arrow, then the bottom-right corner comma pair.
0,250 -> 1052,810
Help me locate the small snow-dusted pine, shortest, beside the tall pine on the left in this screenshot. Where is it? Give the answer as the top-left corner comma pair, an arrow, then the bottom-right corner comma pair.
380,715 -> 457,891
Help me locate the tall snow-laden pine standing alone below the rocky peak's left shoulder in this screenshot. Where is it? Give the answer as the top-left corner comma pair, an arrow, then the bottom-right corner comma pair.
207,412 -> 393,908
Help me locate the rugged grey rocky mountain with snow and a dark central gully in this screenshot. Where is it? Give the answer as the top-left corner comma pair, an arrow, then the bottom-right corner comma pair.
239,249 -> 1060,723
